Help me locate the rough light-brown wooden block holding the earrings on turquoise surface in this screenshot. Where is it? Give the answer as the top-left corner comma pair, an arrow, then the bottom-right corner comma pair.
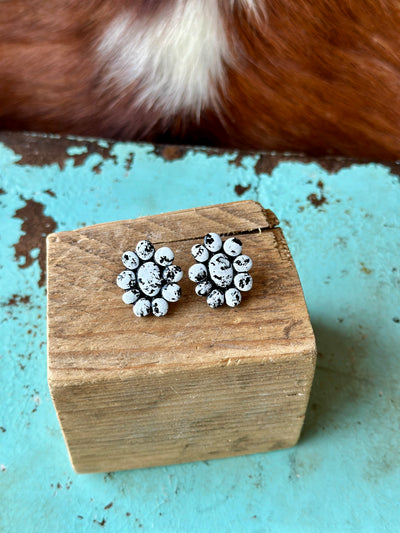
47,201 -> 316,472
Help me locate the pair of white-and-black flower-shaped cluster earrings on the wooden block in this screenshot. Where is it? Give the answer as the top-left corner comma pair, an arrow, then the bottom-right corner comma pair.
117,233 -> 253,317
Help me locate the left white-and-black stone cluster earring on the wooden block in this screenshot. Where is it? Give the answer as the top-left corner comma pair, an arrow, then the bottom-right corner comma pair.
117,240 -> 183,317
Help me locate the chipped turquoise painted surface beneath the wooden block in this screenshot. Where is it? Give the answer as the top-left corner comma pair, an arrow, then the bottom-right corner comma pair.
0,138 -> 400,533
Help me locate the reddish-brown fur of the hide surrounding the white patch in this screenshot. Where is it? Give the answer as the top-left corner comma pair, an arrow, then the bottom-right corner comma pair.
0,0 -> 400,159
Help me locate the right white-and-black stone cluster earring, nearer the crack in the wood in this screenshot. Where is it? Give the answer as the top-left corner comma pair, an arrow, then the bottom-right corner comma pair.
189,233 -> 253,308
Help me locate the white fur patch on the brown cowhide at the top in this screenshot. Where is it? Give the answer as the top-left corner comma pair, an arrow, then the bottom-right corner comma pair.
98,0 -> 231,117
